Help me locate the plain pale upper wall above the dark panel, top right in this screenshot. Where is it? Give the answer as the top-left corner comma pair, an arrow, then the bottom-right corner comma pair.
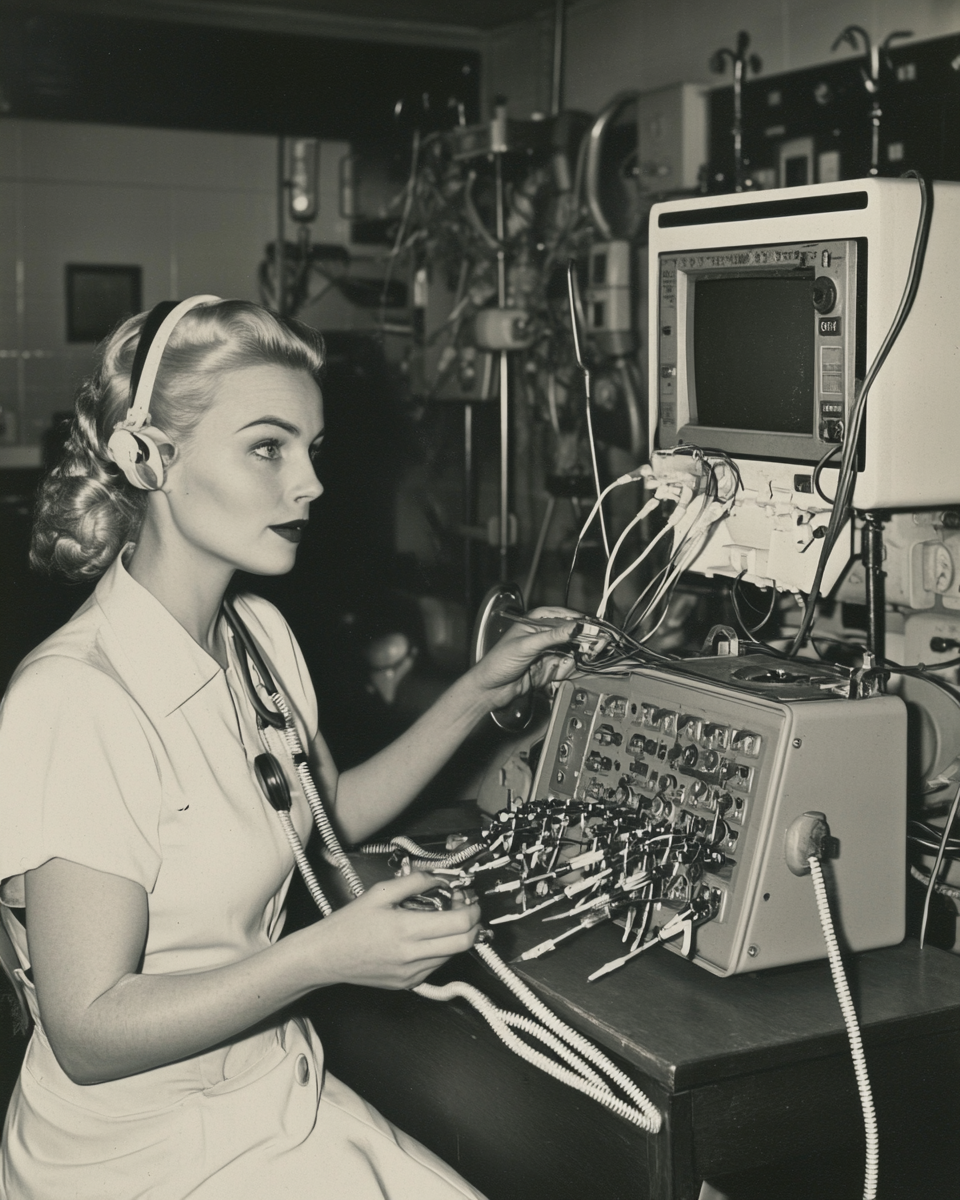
485,0 -> 960,116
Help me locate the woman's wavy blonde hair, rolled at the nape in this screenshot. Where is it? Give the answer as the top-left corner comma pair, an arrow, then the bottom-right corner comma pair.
30,300 -> 324,582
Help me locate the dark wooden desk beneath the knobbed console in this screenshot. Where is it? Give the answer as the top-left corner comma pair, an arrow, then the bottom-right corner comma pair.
302,925 -> 960,1200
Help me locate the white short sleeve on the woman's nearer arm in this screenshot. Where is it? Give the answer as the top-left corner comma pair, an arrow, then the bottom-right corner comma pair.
0,656 -> 161,895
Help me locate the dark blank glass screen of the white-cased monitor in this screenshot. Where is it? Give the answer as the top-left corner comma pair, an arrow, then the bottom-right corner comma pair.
691,271 -> 816,434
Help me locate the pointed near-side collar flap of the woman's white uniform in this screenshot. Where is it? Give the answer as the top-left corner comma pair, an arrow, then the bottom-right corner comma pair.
94,545 -> 221,716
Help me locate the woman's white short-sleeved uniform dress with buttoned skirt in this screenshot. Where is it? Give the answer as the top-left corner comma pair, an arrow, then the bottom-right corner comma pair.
0,559 -> 482,1200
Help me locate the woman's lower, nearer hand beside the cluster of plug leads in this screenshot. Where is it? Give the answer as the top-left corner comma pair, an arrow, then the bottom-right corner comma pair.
302,871 -> 480,989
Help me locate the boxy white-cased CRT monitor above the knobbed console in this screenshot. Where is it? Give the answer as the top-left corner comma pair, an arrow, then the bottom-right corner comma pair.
649,179 -> 960,509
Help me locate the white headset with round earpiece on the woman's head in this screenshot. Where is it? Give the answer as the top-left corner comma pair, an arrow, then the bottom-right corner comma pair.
107,295 -> 221,492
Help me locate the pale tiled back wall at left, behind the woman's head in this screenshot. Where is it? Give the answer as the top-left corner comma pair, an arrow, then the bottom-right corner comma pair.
0,120 -> 349,466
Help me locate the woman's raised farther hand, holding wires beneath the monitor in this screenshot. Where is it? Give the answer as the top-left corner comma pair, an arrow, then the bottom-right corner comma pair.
468,607 -> 583,709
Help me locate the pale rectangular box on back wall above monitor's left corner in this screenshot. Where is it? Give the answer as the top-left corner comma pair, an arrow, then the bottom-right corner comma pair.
637,83 -> 707,196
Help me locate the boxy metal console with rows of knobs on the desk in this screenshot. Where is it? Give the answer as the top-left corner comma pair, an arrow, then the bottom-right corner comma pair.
530,654 -> 906,976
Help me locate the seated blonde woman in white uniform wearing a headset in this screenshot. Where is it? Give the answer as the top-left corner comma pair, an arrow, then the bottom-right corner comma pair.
0,296 -> 574,1200
